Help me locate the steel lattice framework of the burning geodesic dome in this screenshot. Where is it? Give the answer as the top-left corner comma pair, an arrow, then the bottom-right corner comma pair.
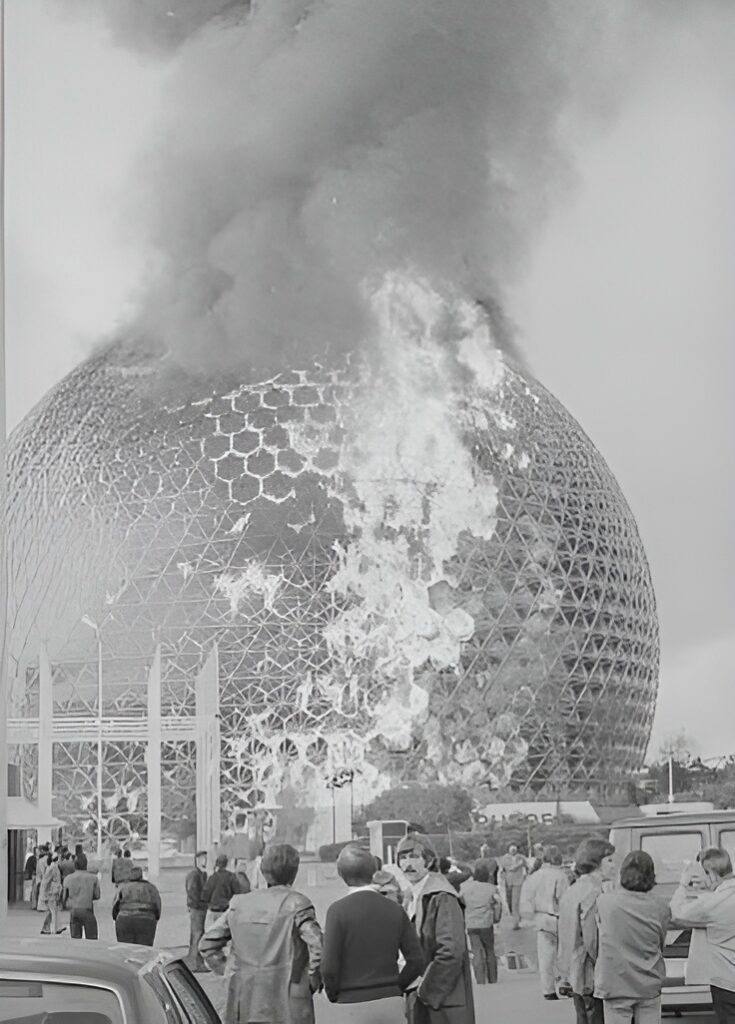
9,342 -> 658,839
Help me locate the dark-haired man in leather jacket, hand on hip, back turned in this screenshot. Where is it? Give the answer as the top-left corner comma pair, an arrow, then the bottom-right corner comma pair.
199,844 -> 323,1024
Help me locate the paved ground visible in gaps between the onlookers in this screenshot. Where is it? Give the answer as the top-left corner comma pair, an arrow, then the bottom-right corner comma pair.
9,864 -> 714,1024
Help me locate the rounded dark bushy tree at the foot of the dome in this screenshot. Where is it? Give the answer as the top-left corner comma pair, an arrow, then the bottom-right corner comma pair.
364,783 -> 472,834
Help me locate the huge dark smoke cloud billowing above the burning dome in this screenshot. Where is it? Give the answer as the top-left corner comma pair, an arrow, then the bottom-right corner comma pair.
67,0 -> 704,366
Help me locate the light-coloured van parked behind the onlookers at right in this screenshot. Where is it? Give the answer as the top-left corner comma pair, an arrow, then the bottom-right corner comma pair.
610,810 -> 735,1014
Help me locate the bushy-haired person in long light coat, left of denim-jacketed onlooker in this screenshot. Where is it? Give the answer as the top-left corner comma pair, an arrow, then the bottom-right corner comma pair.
559,837 -> 615,1024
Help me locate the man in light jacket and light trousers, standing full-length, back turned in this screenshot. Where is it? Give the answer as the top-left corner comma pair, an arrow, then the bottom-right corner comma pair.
521,846 -> 569,999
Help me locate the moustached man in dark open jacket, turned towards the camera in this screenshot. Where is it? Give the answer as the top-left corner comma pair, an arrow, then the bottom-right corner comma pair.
396,833 -> 475,1024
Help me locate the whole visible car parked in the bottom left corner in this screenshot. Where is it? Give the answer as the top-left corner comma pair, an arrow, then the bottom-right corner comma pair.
0,937 -> 221,1024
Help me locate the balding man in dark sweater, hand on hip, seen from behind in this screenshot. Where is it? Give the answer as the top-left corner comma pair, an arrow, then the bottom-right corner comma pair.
321,844 -> 424,1024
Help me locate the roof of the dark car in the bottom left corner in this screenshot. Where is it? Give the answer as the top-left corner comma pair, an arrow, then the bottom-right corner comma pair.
0,936 -> 176,983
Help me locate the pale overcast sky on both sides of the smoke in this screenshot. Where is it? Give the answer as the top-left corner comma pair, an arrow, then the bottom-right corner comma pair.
6,0 -> 735,756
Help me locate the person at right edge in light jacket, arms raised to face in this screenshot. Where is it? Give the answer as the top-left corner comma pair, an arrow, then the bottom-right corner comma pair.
672,847 -> 735,1024
